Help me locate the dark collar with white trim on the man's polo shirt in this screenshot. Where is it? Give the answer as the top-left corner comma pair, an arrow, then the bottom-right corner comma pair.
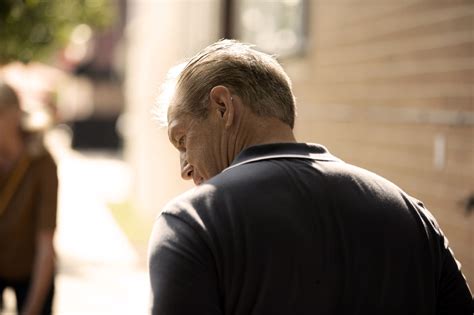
224,143 -> 341,172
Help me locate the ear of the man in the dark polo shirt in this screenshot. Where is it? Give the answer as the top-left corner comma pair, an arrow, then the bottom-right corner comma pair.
209,85 -> 235,128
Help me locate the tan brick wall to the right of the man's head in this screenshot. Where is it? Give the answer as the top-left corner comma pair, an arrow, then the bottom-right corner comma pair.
283,0 -> 474,287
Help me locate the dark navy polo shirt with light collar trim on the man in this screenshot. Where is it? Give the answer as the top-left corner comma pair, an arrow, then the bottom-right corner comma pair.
149,143 -> 472,315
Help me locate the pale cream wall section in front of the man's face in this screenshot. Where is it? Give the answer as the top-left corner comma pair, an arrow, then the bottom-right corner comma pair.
123,0 -> 219,215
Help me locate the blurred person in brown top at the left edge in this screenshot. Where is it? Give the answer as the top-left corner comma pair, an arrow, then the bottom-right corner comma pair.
0,81 -> 58,314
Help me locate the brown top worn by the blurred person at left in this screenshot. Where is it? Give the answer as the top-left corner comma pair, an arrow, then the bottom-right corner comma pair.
0,151 -> 58,280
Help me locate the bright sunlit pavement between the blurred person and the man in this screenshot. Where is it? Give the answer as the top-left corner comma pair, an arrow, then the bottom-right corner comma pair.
4,130 -> 149,315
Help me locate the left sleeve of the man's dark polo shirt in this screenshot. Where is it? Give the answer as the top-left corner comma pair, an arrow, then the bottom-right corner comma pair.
149,213 -> 222,315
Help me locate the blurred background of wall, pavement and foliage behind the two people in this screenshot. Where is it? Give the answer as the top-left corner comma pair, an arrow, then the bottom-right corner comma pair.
0,0 -> 474,314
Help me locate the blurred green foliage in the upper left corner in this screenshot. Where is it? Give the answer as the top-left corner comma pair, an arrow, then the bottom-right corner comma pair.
0,0 -> 115,65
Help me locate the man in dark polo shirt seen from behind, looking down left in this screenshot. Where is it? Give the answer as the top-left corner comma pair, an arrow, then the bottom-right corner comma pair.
149,40 -> 472,315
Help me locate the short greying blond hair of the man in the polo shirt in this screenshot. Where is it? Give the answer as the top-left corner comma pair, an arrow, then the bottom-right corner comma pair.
168,40 -> 296,128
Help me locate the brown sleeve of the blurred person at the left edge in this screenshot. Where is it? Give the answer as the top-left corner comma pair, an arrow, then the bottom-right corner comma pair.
36,154 -> 58,231
